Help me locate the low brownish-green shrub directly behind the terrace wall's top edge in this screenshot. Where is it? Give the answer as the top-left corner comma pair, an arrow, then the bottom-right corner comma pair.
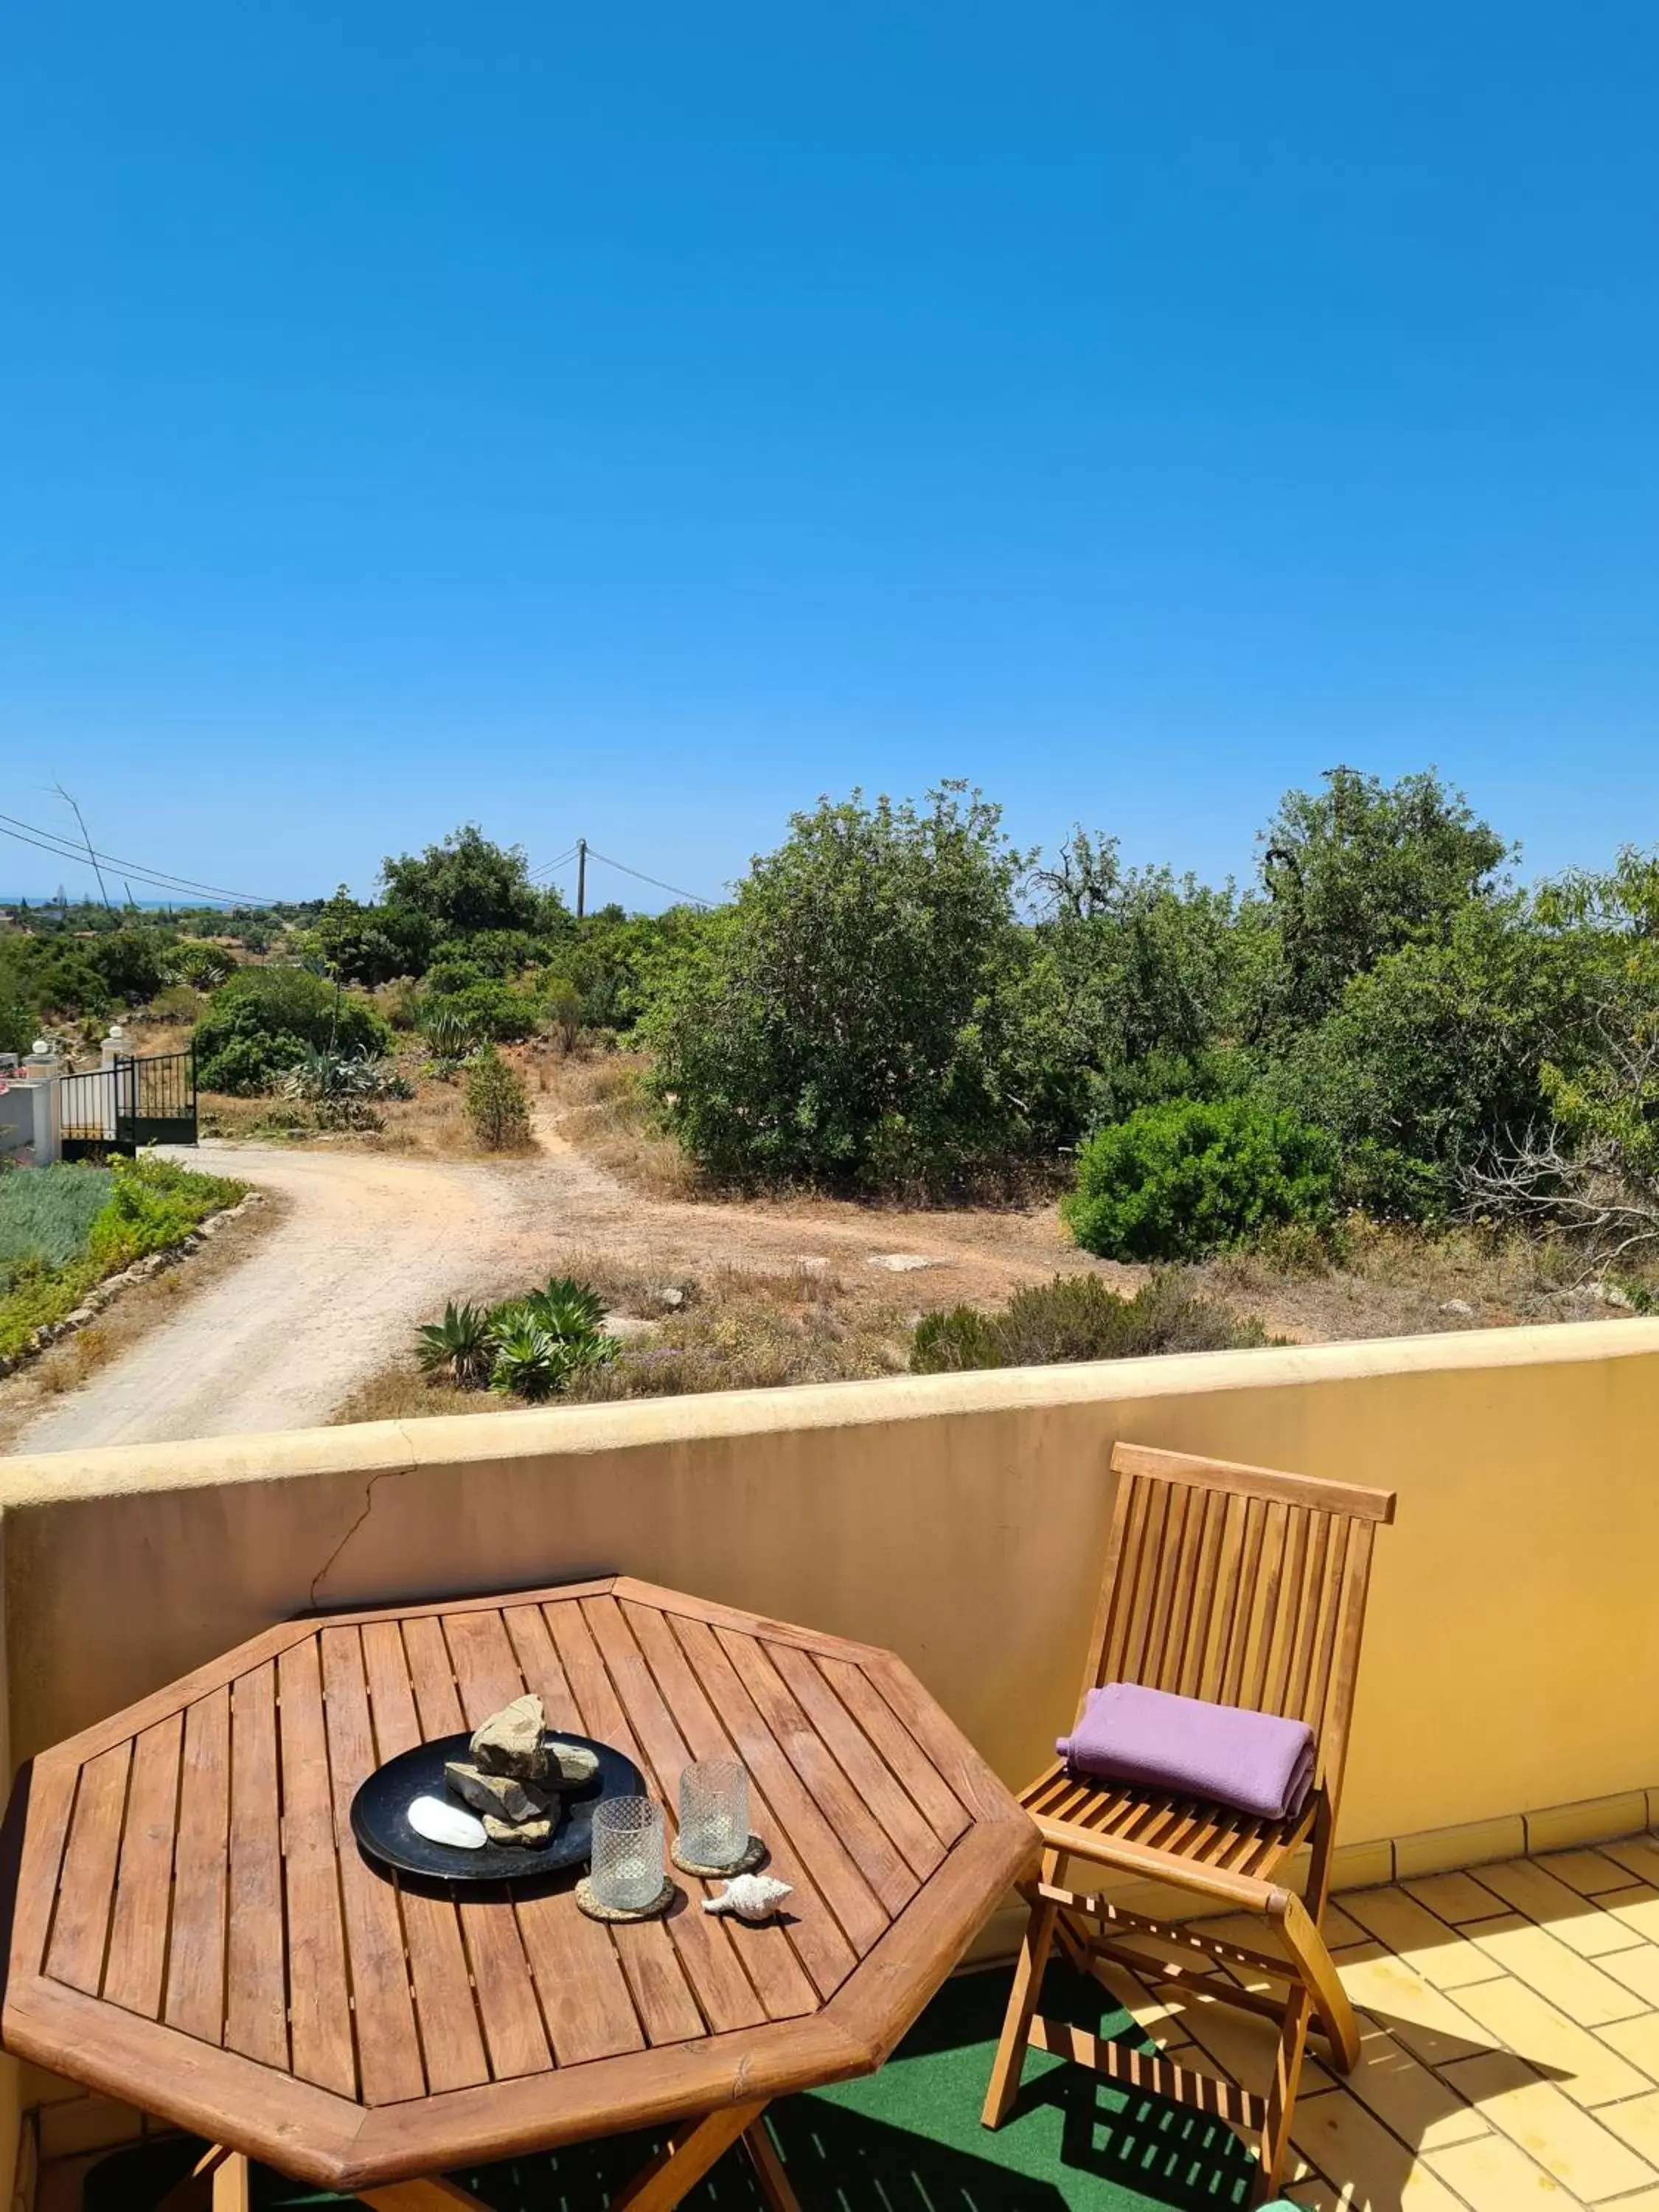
909,1270 -> 1267,1376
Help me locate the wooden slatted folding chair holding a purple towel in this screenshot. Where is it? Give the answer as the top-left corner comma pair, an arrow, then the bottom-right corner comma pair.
982,1444 -> 1394,2203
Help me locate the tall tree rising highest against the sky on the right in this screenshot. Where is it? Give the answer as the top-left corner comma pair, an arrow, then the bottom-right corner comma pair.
1261,768 -> 1511,1026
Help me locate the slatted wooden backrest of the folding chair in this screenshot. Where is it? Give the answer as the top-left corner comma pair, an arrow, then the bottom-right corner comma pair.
1079,1444 -> 1394,1823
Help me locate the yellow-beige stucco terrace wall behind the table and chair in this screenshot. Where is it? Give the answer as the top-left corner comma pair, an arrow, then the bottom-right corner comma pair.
0,1321 -> 1659,1840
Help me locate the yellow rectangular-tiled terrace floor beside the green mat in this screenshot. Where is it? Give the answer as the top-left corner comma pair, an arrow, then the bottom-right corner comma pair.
1097,1836 -> 1659,2212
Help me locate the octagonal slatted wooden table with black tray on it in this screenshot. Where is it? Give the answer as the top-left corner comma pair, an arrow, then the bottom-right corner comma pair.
0,1577 -> 1037,2212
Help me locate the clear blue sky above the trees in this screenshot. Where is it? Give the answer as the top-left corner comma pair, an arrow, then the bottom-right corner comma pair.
0,0 -> 1659,894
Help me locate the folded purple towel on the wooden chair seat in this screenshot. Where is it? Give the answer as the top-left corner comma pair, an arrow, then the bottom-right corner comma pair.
1055,1681 -> 1314,1820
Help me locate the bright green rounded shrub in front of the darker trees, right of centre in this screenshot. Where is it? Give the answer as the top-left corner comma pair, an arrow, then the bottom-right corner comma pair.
1060,1097 -> 1336,1259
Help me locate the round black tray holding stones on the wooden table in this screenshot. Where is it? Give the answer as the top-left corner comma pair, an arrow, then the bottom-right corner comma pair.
352,1730 -> 646,1882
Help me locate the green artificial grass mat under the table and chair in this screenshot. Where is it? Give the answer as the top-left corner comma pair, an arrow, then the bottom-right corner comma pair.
82,1966 -> 1254,2212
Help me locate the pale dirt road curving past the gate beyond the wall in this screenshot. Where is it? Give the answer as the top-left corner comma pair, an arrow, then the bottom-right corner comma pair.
11,1130 -> 1106,1451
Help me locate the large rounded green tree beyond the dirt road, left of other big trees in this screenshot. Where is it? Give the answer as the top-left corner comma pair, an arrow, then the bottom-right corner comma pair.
646,783 -> 1029,1188
